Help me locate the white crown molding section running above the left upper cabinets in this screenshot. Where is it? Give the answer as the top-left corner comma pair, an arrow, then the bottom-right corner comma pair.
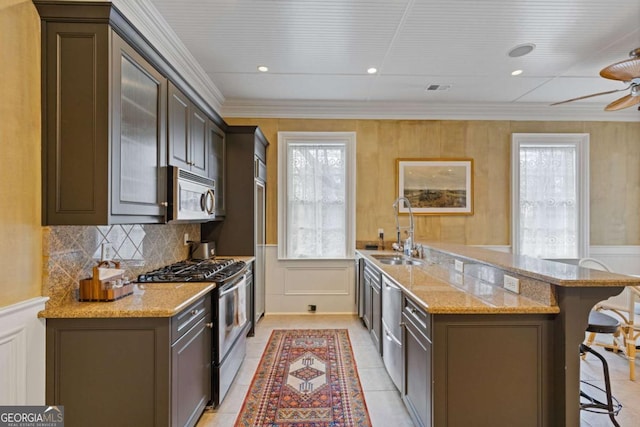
111,0 -> 225,113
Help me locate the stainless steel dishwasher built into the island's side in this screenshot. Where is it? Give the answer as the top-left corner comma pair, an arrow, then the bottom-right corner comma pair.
382,275 -> 403,390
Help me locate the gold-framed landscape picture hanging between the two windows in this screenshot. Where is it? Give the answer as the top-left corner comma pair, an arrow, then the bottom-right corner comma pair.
397,159 -> 473,215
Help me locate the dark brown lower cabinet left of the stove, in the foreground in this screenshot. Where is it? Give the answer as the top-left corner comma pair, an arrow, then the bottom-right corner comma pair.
46,296 -> 212,427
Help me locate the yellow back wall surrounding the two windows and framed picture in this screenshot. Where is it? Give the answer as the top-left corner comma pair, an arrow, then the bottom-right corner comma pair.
226,118 -> 640,249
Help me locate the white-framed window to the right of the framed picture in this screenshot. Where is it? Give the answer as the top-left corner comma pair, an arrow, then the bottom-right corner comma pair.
511,133 -> 589,258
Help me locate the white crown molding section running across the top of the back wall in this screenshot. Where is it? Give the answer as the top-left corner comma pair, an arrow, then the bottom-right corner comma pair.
222,98 -> 640,122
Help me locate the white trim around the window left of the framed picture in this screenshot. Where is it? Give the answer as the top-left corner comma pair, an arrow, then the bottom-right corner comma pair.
278,132 -> 356,261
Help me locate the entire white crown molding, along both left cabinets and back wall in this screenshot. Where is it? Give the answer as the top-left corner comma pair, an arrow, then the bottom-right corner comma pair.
52,0 -> 640,122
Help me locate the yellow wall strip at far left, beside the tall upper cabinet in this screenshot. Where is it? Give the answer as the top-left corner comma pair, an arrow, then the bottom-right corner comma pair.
0,0 -> 42,307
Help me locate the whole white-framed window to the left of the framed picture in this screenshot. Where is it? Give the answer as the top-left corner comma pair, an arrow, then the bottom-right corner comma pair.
278,132 -> 356,259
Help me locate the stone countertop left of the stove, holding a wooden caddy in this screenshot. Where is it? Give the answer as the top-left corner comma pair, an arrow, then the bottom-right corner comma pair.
38,282 -> 215,319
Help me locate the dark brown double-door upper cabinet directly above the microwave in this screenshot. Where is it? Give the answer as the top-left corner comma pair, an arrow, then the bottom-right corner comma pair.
169,83 -> 209,176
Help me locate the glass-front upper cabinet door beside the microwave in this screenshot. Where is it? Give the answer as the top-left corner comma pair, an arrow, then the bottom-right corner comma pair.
111,33 -> 167,222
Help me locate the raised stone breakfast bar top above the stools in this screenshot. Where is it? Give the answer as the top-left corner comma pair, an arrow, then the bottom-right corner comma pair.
424,242 -> 640,287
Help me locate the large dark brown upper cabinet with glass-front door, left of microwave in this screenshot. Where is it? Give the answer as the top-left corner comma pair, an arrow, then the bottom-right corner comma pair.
36,2 -> 167,225
